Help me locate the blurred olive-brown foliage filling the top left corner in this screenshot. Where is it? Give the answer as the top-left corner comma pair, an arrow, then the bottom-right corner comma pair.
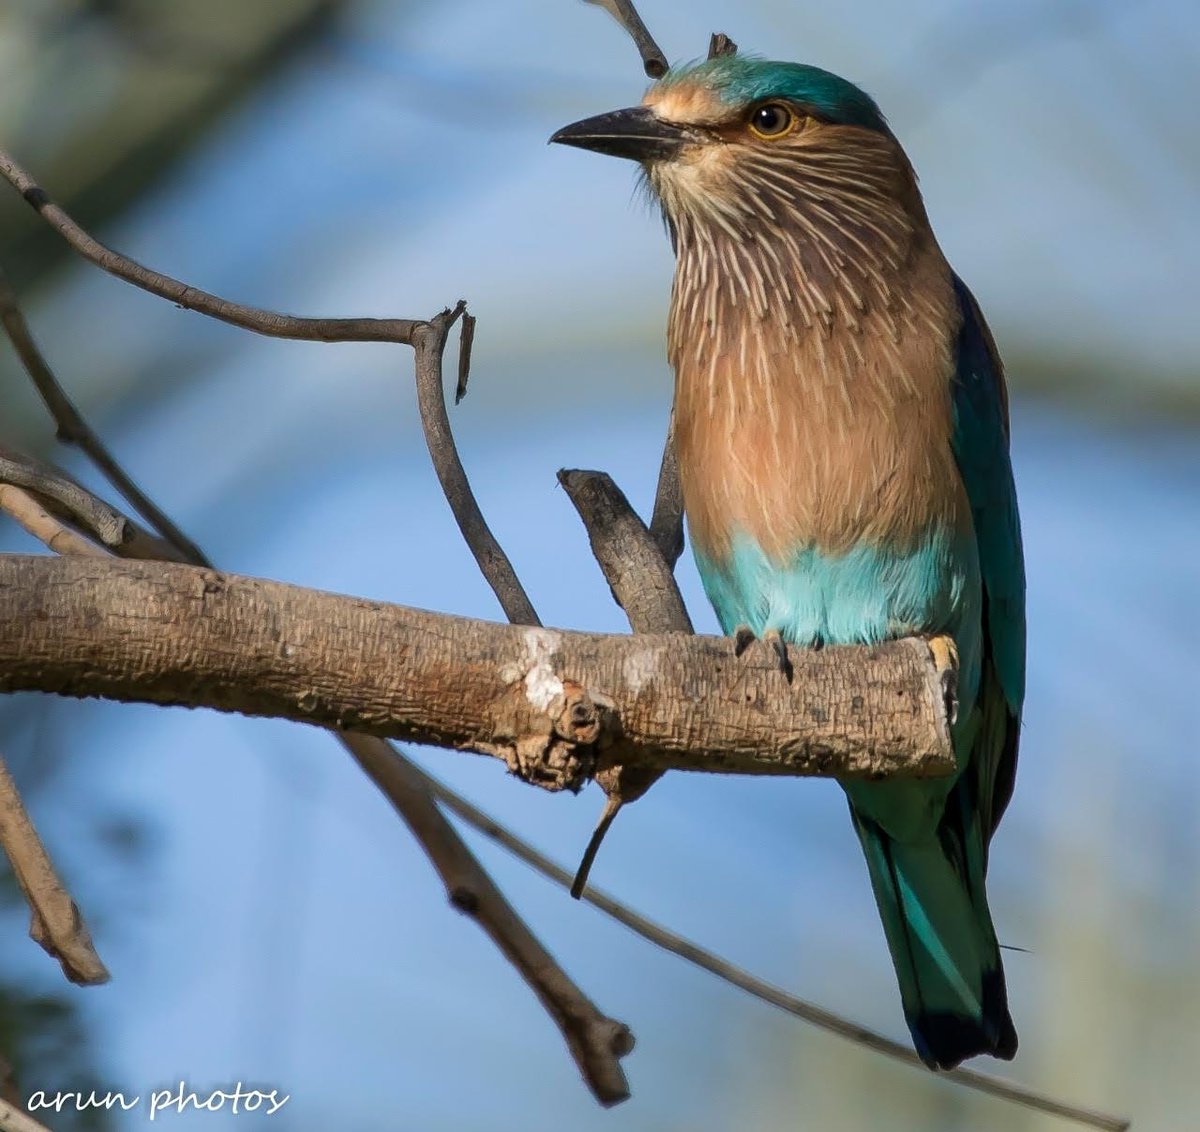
0,0 -> 349,282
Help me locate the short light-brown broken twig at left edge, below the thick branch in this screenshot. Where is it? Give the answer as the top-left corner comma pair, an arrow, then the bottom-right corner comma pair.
0,757 -> 109,987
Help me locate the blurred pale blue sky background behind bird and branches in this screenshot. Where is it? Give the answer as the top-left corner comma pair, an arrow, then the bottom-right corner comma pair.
0,0 -> 1200,1132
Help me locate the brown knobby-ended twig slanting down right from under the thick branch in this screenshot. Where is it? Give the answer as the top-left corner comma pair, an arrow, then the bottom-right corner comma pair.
342,733 -> 634,1106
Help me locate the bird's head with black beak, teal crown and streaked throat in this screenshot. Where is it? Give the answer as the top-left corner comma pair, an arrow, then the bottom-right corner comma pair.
551,55 -> 920,246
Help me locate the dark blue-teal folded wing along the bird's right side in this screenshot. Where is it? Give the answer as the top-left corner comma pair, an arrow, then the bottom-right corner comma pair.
953,277 -> 1025,844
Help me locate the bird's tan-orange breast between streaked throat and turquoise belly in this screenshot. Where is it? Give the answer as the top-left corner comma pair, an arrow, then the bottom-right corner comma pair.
668,226 -> 965,562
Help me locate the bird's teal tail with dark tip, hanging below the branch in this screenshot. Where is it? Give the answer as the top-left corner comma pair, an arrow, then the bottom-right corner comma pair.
851,795 -> 1016,1070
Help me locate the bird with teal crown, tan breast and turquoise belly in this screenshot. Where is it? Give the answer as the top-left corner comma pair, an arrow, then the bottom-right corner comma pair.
551,49 -> 1025,1070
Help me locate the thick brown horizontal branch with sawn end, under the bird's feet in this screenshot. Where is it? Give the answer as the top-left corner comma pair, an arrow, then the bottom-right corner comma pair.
0,556 -> 954,789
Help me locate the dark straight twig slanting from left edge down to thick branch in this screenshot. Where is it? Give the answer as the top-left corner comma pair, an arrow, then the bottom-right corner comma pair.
0,266 -> 208,565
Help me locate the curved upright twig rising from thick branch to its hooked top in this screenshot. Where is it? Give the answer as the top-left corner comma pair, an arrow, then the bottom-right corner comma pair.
413,303 -> 541,625
